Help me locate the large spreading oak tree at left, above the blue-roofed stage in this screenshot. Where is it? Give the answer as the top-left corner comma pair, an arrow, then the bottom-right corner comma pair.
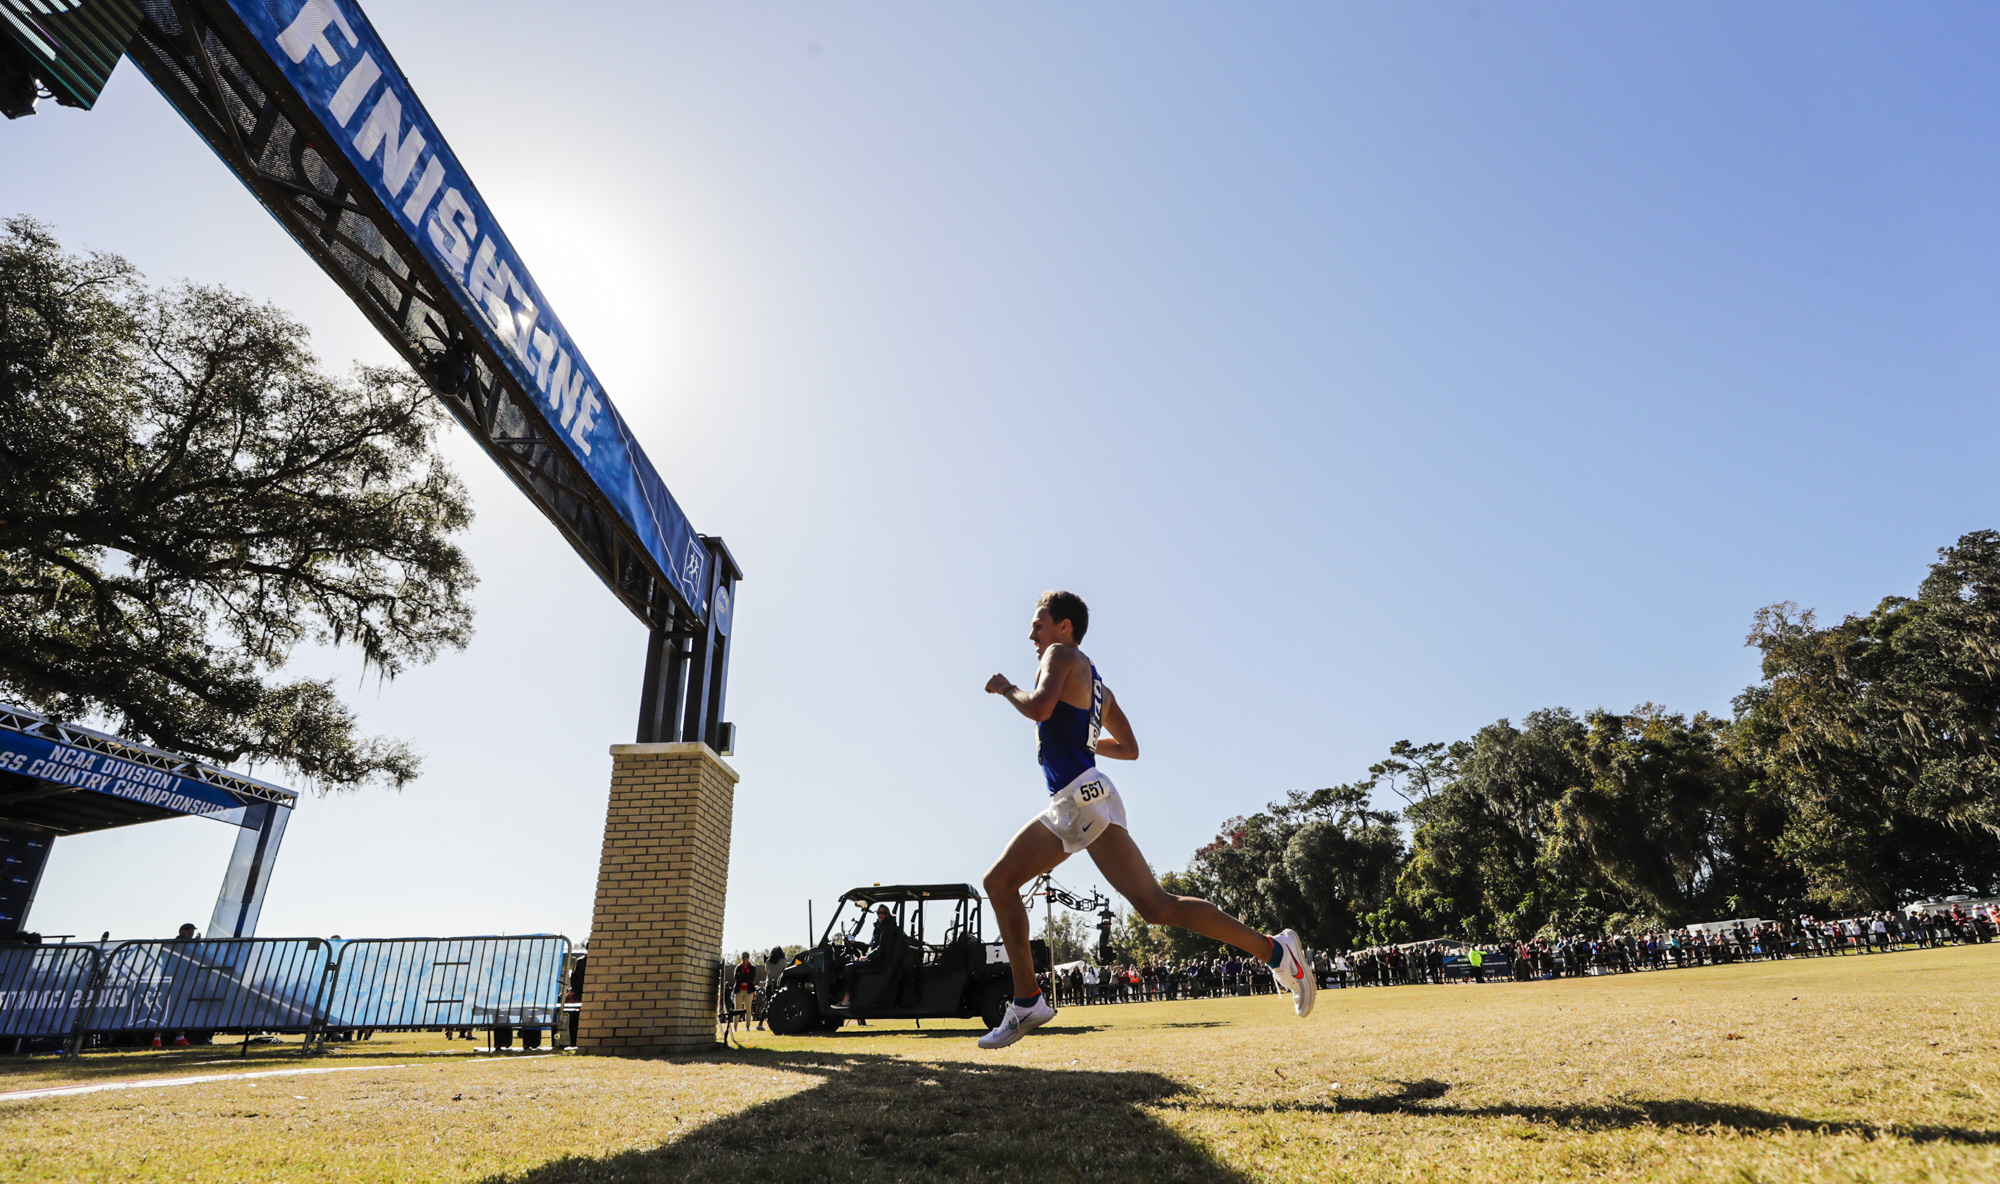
0,218 -> 474,788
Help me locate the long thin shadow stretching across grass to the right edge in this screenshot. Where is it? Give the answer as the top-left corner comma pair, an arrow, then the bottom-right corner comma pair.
1160,1078 -> 2000,1144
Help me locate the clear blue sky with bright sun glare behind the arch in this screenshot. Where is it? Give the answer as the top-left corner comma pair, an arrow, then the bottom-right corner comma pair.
0,0 -> 2000,948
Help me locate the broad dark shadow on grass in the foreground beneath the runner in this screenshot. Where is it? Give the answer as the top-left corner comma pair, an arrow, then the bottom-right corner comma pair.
484,1048 -> 1248,1184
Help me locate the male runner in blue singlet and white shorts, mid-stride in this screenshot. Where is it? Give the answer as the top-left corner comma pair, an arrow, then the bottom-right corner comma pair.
980,592 -> 1318,1048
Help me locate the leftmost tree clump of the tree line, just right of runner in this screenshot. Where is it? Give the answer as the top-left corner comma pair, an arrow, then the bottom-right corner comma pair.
1188,782 -> 1404,948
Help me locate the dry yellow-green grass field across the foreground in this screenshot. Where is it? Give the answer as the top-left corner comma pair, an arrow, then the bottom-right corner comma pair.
0,944 -> 2000,1184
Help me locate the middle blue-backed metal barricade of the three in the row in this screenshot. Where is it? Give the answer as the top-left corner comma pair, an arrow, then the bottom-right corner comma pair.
78,938 -> 328,1032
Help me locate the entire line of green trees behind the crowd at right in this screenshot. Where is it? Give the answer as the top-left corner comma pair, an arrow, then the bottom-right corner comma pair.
1116,530 -> 2000,958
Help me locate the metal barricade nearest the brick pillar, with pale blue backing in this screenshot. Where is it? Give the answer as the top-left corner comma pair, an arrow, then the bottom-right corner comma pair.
324,934 -> 570,1028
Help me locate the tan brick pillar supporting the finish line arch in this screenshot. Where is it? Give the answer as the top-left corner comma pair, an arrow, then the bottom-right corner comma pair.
576,744 -> 736,1056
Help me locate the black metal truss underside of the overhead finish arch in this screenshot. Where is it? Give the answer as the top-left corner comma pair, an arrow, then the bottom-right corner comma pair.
128,0 -> 702,636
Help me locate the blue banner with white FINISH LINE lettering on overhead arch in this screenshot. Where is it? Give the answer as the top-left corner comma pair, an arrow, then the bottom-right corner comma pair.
230,0 -> 710,618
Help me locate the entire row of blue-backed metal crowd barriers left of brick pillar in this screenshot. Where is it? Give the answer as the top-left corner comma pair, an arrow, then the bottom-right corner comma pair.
0,934 -> 570,1056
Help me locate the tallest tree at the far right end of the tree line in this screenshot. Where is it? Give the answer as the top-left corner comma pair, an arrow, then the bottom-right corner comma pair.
1736,530 -> 2000,910
